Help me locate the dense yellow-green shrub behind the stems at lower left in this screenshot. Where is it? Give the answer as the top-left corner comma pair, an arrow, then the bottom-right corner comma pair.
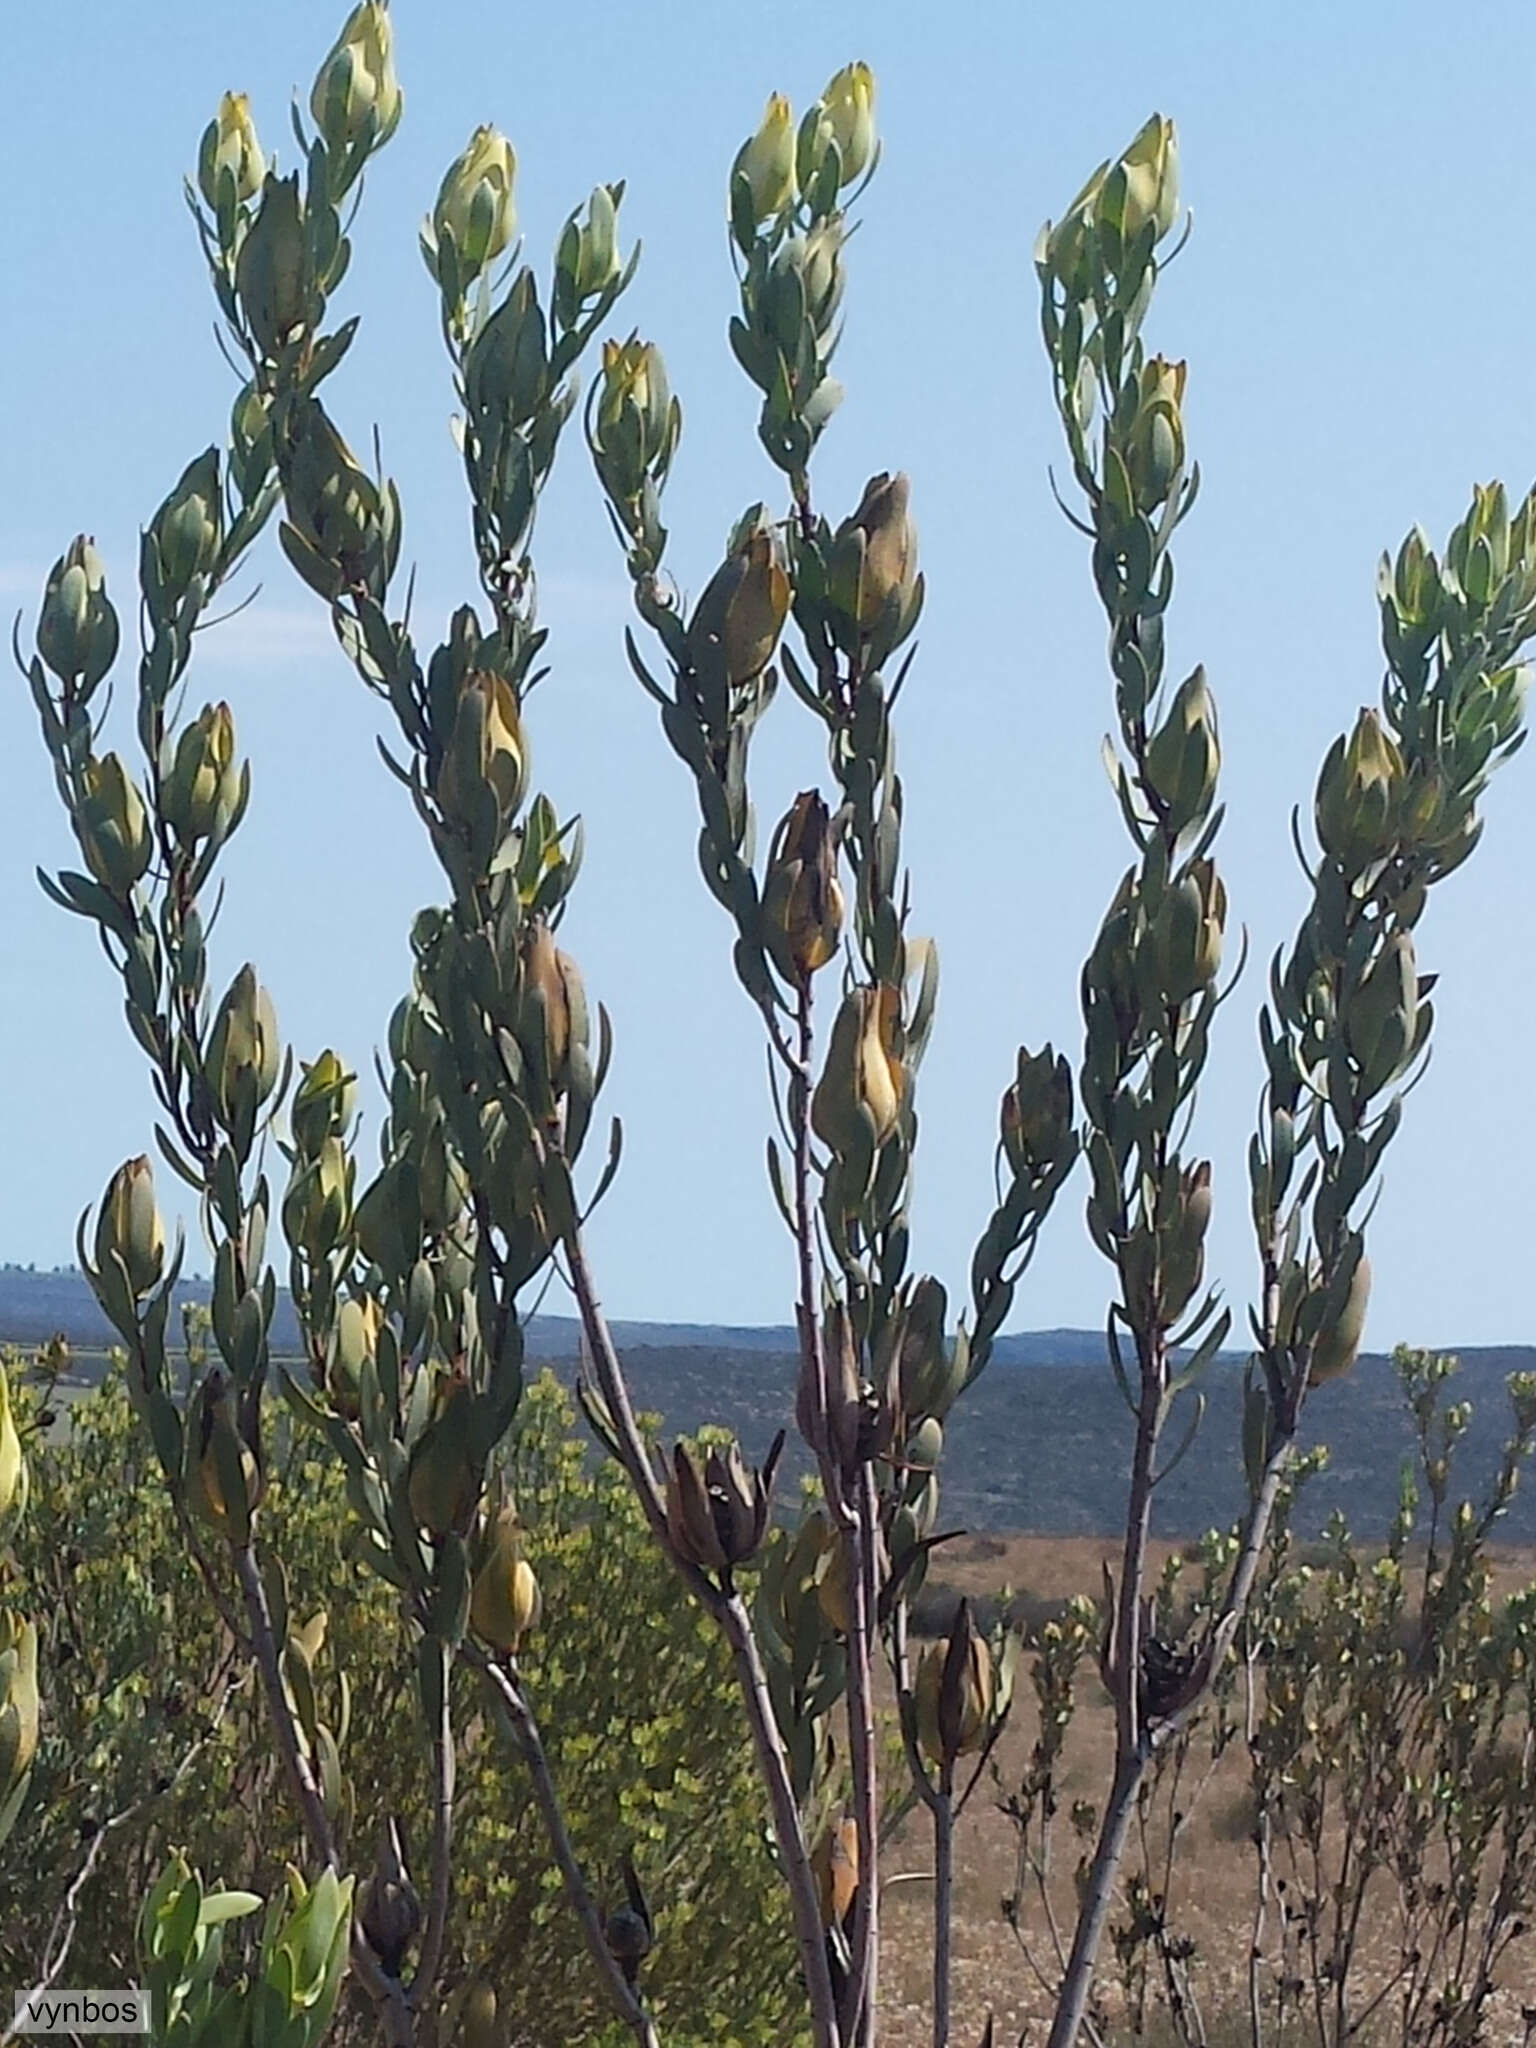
0,1372 -> 803,2044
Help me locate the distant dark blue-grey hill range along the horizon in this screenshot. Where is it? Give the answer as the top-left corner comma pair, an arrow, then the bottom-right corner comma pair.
0,1266 -> 1536,1544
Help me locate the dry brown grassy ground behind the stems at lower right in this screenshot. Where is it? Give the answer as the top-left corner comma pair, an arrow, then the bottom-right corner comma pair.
881,1536 -> 1536,2048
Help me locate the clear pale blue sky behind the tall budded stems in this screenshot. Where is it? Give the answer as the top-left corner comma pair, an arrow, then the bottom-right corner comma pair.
0,0 -> 1536,1346
